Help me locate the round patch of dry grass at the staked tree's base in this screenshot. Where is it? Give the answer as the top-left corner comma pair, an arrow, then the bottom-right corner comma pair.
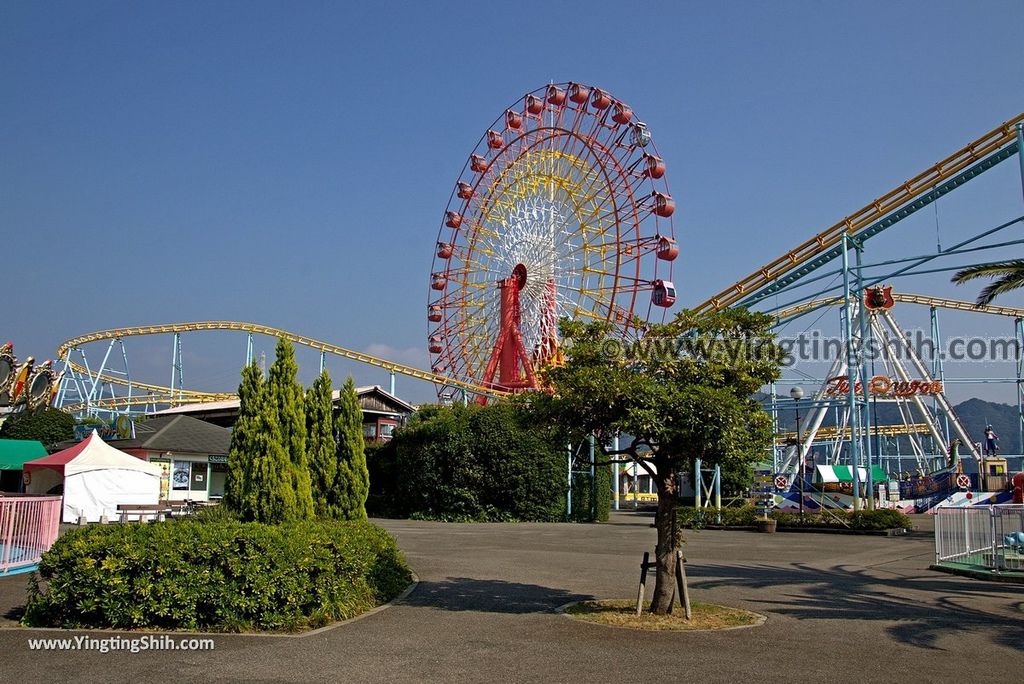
564,599 -> 765,632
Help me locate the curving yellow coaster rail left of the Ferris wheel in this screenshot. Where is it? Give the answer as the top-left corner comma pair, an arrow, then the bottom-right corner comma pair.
56,320 -> 505,411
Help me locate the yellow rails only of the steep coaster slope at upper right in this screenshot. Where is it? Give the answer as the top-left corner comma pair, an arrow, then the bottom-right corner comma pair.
693,114 -> 1024,311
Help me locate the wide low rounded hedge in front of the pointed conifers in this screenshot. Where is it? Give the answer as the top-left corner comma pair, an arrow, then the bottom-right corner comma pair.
23,520 -> 411,632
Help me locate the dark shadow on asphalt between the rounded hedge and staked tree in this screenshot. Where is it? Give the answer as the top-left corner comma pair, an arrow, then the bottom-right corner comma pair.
398,578 -> 594,613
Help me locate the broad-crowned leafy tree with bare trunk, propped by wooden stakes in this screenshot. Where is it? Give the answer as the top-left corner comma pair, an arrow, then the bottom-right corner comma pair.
534,309 -> 782,613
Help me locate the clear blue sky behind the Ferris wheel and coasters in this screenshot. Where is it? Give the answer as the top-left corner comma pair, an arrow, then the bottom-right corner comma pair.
0,0 -> 1024,401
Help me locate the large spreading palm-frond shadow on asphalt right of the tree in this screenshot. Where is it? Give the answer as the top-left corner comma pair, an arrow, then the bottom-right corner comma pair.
689,563 -> 1024,651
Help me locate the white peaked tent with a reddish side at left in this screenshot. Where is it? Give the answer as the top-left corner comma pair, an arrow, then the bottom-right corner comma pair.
25,430 -> 161,522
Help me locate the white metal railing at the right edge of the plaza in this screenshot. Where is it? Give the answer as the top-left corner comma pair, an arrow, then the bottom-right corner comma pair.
935,504 -> 1024,571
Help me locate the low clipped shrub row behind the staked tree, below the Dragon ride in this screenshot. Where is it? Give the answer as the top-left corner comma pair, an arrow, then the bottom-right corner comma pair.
676,505 -> 911,530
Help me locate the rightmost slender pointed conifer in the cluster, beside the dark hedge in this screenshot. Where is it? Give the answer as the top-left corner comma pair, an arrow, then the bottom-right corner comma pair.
331,376 -> 370,520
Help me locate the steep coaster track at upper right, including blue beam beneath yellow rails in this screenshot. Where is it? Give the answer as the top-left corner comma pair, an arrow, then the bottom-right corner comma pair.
693,114 -> 1024,311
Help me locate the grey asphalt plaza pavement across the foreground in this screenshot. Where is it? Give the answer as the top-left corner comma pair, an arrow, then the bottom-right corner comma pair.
0,513 -> 1024,684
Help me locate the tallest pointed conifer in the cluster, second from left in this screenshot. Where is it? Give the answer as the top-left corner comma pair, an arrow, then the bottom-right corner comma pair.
267,338 -> 313,520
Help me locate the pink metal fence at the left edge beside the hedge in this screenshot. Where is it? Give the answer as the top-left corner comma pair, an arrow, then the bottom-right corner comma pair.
0,496 -> 60,575
